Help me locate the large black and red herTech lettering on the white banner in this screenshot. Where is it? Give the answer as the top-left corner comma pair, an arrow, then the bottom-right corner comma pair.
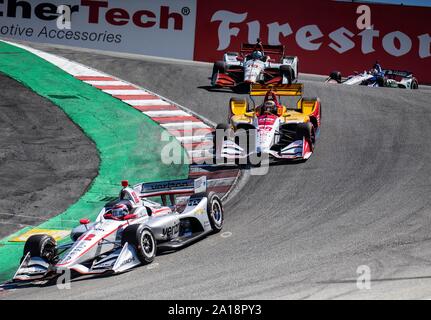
0,0 -> 185,30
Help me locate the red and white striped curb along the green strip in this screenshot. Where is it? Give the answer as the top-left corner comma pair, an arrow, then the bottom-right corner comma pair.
4,41 -> 240,196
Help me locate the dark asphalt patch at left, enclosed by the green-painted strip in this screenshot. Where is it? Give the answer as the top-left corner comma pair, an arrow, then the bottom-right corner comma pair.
0,73 -> 99,238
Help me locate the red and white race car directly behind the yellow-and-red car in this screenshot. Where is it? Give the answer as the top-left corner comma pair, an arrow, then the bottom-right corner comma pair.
211,42 -> 298,88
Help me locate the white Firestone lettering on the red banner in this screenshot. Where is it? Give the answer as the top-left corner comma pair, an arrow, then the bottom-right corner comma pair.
211,10 -> 431,58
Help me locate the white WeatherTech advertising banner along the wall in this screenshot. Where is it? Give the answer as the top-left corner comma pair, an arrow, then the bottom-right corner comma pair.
0,0 -> 196,60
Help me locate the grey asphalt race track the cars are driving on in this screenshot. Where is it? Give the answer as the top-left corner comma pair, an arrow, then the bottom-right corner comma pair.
3,46 -> 431,299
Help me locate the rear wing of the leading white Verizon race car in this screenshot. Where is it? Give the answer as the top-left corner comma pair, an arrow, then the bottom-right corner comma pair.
135,176 -> 207,198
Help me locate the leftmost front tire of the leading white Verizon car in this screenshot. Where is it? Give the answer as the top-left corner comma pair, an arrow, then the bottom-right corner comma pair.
21,234 -> 57,263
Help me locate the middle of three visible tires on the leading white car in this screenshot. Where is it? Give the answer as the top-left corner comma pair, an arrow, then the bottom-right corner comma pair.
121,224 -> 157,264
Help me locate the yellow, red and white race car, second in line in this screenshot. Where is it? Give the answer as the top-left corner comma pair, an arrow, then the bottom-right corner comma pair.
215,83 -> 322,160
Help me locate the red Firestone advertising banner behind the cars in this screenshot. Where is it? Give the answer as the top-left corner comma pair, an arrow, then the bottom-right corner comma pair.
194,0 -> 431,83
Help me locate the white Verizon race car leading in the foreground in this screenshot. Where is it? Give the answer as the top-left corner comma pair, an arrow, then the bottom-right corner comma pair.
13,177 -> 223,282
